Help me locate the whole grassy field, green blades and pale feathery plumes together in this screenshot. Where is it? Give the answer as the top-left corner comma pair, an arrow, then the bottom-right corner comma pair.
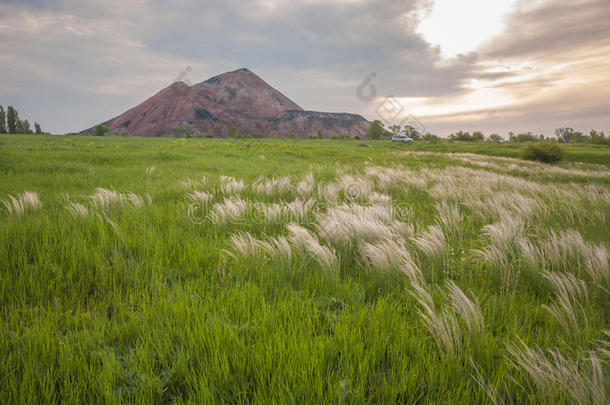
0,135 -> 610,404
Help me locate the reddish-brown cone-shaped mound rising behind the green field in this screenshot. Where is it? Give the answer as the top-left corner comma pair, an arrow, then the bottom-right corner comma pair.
88,69 -> 370,137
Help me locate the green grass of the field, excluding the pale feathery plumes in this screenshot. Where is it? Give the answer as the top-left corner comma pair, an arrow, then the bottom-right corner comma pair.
0,135 -> 610,404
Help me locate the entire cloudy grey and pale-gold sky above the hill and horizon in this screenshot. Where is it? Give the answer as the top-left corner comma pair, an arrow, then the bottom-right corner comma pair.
0,0 -> 610,136
